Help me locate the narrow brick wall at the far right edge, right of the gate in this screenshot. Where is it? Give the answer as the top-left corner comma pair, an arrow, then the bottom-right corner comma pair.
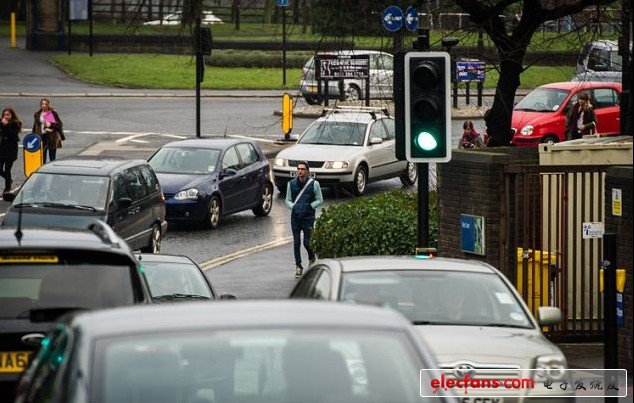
605,167 -> 634,369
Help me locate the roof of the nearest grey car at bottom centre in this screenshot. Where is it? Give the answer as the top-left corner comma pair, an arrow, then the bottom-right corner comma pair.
72,300 -> 409,338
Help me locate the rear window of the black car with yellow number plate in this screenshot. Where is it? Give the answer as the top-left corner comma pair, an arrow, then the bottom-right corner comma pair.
0,264 -> 134,319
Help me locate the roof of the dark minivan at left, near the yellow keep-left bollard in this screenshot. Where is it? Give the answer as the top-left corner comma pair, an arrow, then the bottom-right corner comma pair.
37,156 -> 147,176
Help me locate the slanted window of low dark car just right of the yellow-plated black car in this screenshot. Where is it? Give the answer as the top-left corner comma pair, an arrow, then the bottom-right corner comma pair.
141,260 -> 213,299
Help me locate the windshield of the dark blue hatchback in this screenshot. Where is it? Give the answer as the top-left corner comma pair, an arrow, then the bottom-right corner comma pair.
148,147 -> 220,175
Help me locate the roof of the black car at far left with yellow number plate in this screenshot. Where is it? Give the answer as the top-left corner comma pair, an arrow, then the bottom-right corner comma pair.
0,228 -> 129,254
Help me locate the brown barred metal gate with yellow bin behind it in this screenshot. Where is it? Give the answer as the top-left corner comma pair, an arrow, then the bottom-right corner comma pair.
501,165 -> 607,341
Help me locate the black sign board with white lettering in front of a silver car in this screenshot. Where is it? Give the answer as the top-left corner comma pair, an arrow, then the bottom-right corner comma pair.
315,55 -> 370,80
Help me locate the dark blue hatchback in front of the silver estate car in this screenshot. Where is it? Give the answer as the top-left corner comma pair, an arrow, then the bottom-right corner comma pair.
148,139 -> 273,228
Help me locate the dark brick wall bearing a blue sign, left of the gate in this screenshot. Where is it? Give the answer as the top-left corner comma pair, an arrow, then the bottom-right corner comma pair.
438,148 -> 538,276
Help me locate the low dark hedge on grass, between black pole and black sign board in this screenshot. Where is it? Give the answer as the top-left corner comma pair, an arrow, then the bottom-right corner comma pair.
205,49 -> 314,69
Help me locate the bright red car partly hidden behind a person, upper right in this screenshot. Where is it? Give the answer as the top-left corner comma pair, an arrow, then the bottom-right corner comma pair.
511,82 -> 621,147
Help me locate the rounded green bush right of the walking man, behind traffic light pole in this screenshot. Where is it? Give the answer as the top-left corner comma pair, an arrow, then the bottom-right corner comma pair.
312,190 -> 438,258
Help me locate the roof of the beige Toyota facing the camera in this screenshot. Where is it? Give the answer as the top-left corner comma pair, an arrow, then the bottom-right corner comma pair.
323,256 -> 497,273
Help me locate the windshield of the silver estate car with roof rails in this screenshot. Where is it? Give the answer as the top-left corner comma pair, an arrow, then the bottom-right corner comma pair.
297,121 -> 368,146
